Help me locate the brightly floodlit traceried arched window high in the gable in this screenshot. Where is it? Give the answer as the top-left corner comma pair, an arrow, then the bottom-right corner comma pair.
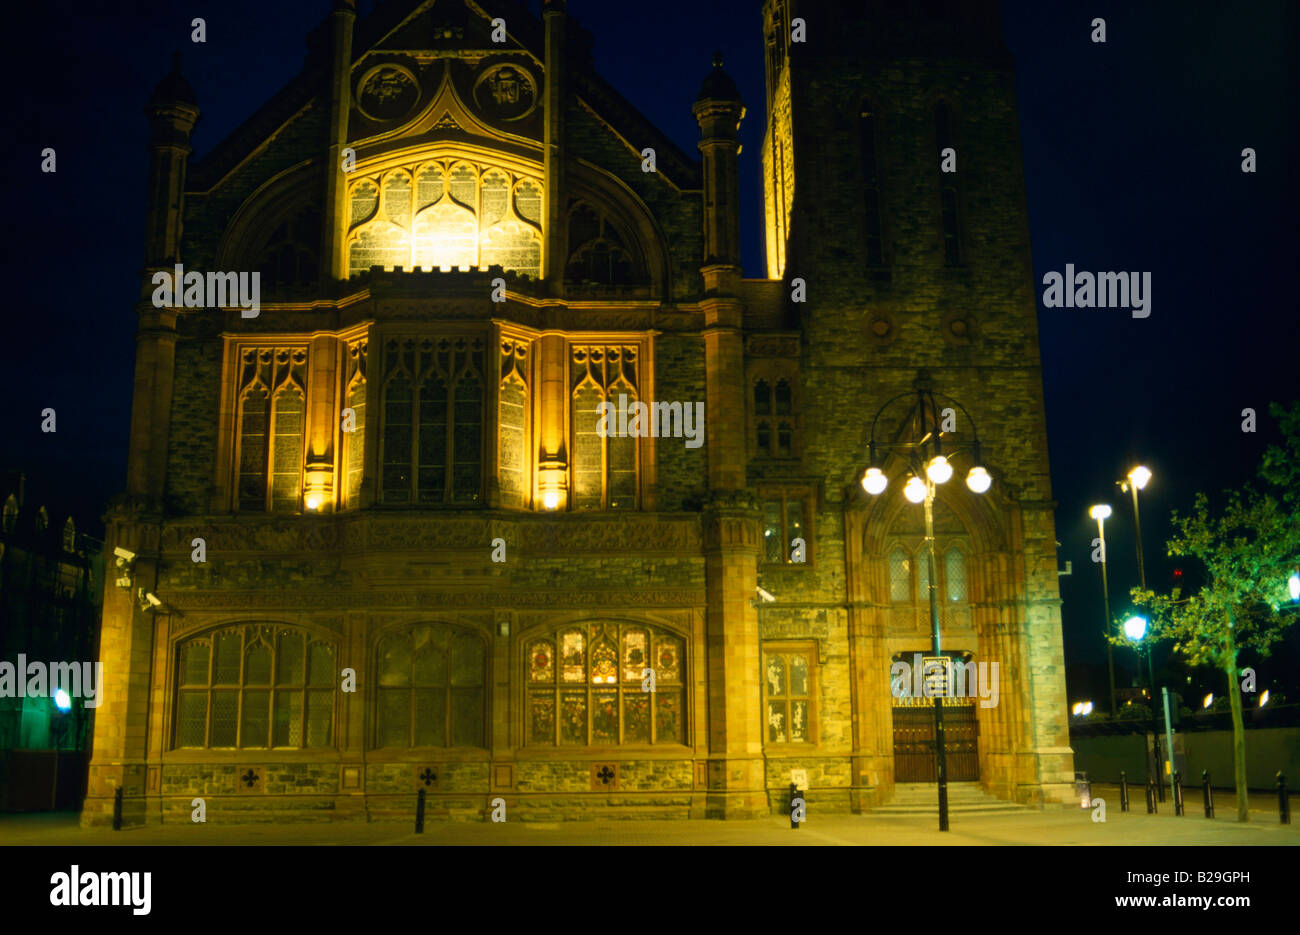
347,157 -> 542,280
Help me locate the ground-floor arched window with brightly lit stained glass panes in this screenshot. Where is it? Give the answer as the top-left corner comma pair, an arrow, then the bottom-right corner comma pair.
524,623 -> 686,746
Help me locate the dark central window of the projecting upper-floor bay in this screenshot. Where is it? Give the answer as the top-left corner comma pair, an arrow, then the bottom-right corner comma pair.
380,337 -> 484,506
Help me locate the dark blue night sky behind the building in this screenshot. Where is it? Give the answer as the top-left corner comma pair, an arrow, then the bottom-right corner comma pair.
0,0 -> 1300,696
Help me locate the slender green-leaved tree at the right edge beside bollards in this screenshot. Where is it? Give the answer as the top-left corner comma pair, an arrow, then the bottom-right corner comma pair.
1131,403 -> 1300,822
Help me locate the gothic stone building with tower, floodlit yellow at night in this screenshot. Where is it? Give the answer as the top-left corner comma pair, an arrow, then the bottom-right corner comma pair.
83,0 -> 1073,823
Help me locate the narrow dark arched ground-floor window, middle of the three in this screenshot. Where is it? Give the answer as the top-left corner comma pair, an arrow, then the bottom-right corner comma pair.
374,623 -> 486,748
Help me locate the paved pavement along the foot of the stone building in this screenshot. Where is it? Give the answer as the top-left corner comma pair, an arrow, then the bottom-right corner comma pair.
0,789 -> 1300,847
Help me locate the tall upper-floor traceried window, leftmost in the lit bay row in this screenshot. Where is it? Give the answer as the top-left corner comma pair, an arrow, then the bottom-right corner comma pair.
235,347 -> 307,512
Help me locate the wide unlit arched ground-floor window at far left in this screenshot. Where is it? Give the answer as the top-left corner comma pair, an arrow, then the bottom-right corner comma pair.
173,624 -> 337,749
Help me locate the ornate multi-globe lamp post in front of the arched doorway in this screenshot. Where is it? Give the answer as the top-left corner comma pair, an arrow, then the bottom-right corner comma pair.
862,386 -> 993,831
